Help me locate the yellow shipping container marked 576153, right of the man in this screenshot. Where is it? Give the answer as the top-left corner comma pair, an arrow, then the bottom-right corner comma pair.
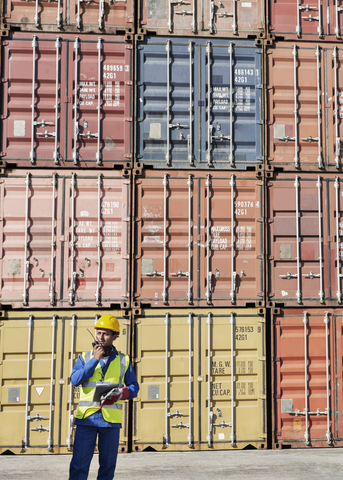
133,309 -> 267,451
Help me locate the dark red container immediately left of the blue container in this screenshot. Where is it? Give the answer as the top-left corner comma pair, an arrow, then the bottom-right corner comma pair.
1,31 -> 133,169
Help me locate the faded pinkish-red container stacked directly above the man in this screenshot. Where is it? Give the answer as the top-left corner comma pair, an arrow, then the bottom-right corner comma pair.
0,170 -> 130,309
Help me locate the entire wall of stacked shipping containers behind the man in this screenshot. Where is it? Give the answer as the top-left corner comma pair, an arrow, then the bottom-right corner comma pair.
0,0 -> 343,453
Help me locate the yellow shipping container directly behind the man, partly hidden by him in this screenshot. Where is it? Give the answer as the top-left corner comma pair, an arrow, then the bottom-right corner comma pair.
0,310 -> 131,454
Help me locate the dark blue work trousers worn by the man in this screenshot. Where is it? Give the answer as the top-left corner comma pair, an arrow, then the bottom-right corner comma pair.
69,425 -> 120,480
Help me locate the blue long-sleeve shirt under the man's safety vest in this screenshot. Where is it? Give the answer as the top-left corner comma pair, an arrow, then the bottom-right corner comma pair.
70,350 -> 139,428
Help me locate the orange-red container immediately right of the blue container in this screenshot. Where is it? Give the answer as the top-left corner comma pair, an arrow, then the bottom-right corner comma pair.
266,42 -> 343,171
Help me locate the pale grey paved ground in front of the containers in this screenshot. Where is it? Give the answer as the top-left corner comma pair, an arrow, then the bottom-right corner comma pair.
0,448 -> 343,480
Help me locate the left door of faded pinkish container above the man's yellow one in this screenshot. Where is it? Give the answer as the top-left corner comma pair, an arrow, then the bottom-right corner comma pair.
1,173 -> 61,308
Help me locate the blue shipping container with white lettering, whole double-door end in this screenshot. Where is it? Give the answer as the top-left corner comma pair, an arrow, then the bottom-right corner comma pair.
135,37 -> 264,169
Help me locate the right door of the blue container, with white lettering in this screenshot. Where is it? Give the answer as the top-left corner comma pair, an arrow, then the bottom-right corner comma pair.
201,42 -> 263,168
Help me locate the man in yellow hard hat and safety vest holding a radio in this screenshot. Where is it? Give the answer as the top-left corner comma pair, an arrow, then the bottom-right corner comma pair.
69,314 -> 139,480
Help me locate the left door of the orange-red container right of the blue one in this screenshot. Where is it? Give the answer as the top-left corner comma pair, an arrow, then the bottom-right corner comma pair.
267,44 -> 331,170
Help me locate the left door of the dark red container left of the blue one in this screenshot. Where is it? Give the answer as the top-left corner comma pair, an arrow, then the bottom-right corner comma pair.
2,34 -> 65,167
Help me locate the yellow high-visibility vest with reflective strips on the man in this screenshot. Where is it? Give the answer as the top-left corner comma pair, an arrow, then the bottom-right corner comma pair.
76,350 -> 130,423
